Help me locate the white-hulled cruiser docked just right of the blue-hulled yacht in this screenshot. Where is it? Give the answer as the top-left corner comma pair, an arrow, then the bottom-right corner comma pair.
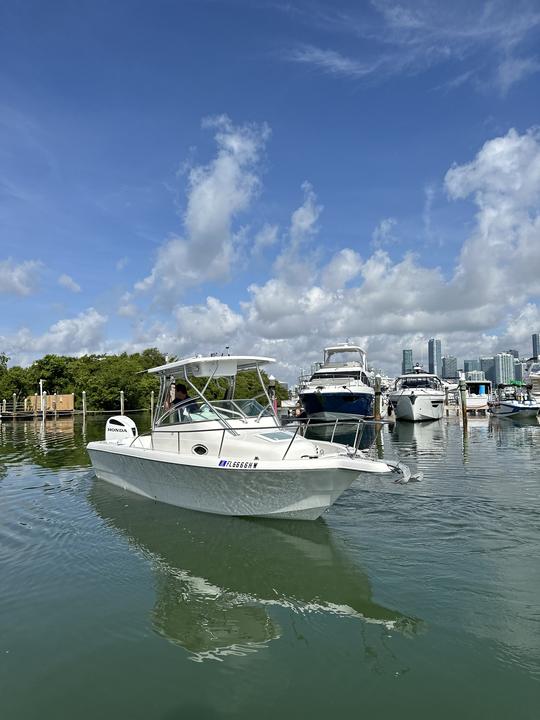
389,367 -> 445,422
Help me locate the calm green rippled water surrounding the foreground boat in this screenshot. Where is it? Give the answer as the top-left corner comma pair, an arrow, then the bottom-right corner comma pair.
0,416 -> 540,720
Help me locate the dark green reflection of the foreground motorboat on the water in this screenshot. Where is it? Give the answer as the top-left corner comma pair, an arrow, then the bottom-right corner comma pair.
89,480 -> 418,661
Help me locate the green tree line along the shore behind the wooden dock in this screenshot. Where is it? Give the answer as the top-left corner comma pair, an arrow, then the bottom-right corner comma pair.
0,348 -> 287,411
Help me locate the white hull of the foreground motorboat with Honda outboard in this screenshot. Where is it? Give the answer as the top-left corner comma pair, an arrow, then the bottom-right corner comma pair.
88,442 -> 389,520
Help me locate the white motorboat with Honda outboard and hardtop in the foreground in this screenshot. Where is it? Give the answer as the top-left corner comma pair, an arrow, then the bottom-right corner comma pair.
87,356 -> 408,520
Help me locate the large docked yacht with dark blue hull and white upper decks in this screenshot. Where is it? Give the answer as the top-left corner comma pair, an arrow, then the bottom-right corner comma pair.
298,343 -> 375,421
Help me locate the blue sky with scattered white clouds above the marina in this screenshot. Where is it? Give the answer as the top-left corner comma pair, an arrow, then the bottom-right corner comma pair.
0,0 -> 540,380
